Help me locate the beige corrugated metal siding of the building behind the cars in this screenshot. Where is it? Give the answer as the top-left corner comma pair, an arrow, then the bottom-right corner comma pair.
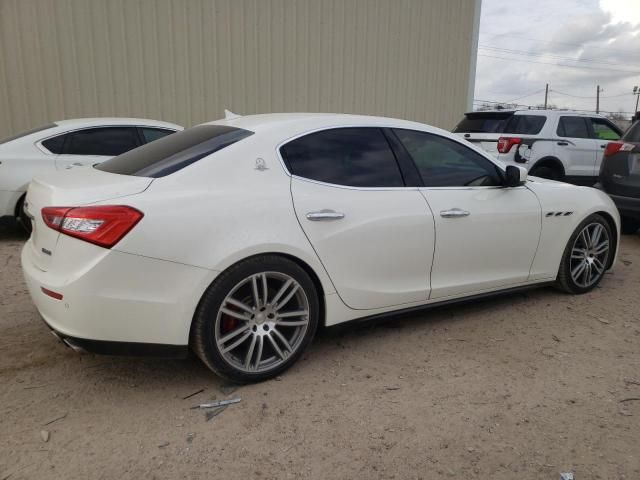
0,0 -> 475,137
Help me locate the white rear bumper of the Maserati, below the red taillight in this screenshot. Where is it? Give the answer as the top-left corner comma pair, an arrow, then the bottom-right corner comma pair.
22,237 -> 215,348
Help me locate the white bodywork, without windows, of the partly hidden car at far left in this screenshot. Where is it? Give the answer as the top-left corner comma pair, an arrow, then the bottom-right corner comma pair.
0,117 -> 183,217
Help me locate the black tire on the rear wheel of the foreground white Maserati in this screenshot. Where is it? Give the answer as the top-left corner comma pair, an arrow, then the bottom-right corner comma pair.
190,255 -> 320,383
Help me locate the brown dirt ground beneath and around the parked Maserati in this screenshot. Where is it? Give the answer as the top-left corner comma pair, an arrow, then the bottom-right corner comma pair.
0,218 -> 640,480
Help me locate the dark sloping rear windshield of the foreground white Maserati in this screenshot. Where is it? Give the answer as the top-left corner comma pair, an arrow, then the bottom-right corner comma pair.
95,125 -> 253,178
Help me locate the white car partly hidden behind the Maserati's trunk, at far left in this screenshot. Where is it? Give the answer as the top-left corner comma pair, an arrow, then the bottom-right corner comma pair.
0,118 -> 182,230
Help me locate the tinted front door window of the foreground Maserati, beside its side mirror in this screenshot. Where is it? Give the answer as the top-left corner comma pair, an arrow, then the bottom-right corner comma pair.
394,130 -> 501,187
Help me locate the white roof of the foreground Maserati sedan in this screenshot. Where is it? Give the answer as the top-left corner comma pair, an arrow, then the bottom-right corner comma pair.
204,113 -> 450,138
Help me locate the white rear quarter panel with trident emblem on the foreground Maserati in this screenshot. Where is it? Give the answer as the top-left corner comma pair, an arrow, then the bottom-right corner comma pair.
107,135 -> 335,294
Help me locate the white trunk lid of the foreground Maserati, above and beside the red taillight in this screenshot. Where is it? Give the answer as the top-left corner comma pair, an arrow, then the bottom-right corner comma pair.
26,167 -> 153,271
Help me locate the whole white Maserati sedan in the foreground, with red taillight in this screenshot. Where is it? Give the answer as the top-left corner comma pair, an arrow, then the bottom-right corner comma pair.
22,114 -> 620,382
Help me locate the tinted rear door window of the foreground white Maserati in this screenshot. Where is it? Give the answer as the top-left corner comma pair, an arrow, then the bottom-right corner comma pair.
280,128 -> 404,187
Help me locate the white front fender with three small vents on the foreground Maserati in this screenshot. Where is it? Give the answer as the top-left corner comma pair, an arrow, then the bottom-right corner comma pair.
527,181 -> 620,280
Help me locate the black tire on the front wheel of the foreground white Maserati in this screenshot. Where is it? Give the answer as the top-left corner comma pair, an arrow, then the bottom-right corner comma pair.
556,214 -> 615,294
